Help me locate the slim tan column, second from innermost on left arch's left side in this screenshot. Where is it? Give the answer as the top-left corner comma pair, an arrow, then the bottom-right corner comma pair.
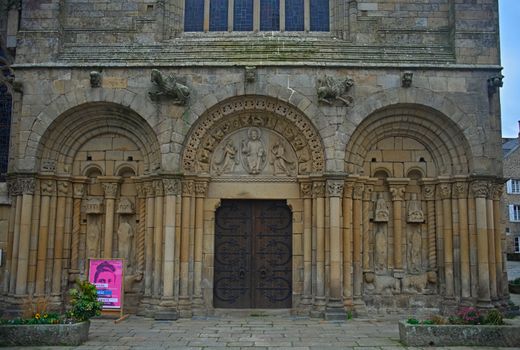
52,180 -> 71,296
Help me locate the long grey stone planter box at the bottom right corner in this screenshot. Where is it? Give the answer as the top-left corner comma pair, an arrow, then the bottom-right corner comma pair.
399,321 -> 520,347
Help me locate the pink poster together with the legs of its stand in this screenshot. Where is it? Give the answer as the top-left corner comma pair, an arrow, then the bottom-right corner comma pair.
87,258 -> 130,323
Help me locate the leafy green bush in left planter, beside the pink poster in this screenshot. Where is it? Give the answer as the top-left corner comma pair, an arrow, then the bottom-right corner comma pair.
67,280 -> 103,322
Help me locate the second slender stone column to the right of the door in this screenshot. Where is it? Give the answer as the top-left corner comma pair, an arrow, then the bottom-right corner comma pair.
313,182 -> 325,311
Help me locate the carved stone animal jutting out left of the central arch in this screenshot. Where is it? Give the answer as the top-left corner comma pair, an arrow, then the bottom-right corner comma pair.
148,69 -> 190,105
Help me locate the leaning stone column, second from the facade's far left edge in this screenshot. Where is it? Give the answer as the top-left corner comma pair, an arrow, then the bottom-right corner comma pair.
16,178 -> 35,295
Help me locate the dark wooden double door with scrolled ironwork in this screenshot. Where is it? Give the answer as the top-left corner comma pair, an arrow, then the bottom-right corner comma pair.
213,200 -> 292,309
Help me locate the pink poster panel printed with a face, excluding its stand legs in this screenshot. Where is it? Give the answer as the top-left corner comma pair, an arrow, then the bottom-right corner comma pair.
88,259 -> 123,309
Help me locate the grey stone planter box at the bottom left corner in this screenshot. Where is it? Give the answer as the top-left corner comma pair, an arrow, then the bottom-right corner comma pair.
0,321 -> 90,346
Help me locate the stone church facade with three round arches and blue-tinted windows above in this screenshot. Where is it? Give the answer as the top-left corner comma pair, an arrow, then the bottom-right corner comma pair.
0,0 -> 508,318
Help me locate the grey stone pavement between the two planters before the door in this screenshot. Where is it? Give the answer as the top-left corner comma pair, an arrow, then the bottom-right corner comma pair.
6,316 -> 520,350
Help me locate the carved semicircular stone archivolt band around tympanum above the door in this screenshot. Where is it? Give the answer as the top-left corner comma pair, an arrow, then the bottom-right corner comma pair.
182,96 -> 325,175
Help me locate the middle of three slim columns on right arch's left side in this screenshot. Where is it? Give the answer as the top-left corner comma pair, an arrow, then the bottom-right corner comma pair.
352,183 -> 365,304
